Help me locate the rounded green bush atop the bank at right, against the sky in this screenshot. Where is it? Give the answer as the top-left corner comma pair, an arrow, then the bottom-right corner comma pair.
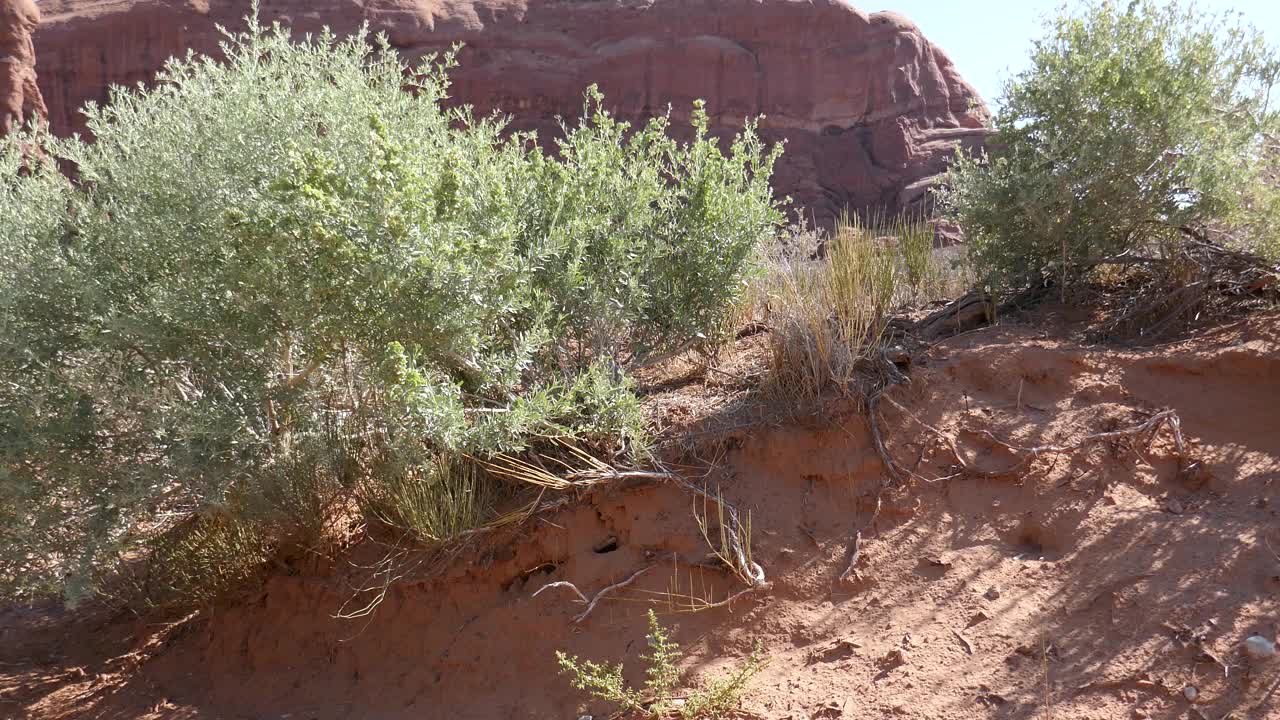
942,0 -> 1280,288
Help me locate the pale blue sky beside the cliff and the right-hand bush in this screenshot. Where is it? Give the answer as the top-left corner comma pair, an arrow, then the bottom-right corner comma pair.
880,0 -> 1280,109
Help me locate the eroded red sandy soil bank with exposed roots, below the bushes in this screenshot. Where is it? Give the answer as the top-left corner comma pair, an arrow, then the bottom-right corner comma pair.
0,315 -> 1280,720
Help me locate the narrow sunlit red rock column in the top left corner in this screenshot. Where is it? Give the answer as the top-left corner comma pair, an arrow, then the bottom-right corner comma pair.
0,0 -> 45,136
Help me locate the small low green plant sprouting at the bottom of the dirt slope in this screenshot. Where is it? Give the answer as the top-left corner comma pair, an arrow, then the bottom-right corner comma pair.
556,610 -> 765,720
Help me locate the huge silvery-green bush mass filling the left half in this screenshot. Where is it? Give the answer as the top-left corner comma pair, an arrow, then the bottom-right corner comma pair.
0,14 -> 780,600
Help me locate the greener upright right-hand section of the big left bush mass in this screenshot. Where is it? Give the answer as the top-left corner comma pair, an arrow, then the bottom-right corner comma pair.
526,88 -> 781,363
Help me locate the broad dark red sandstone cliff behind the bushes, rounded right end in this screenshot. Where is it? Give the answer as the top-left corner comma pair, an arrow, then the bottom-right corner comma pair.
36,0 -> 987,222
